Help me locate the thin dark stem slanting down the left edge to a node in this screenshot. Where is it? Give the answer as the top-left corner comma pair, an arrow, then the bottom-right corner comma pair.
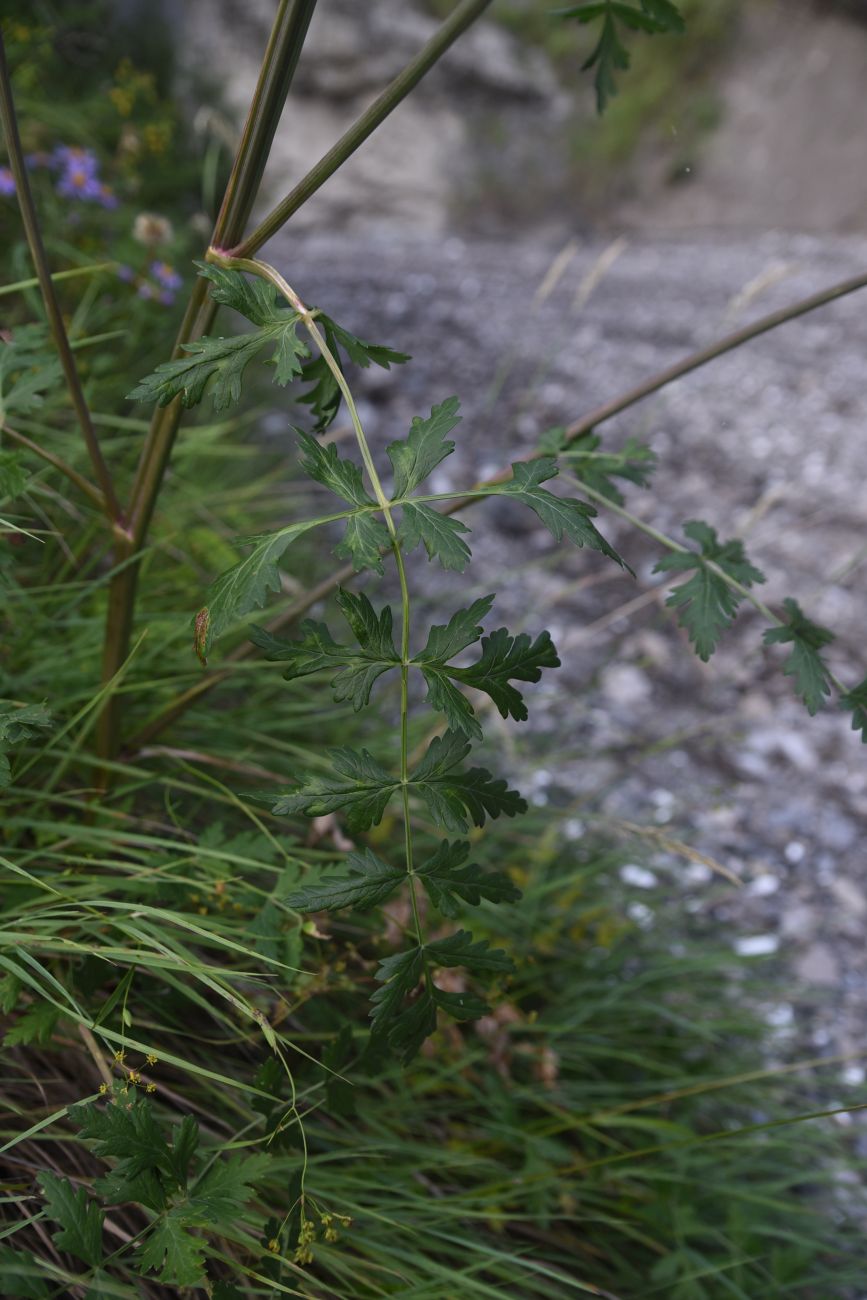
0,33 -> 123,534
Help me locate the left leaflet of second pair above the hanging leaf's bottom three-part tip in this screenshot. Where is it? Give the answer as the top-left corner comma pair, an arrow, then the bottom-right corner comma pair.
265,749 -> 400,831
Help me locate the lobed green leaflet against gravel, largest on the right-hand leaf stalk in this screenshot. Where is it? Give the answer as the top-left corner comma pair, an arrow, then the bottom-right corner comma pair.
654,519 -> 764,663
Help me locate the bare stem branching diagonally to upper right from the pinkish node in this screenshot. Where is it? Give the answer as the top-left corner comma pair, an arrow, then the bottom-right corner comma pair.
232,0 -> 491,257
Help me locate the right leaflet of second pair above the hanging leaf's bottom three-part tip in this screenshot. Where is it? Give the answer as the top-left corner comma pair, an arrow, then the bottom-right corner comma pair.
409,731 -> 526,832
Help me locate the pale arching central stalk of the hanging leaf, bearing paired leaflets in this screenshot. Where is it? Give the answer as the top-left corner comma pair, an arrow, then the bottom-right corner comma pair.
222,248 -> 430,946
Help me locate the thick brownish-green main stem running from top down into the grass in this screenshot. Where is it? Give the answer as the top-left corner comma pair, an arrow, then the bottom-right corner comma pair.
96,0 -> 316,777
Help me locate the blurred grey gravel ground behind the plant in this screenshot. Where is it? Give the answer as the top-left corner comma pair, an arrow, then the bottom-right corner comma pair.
269,226 -> 867,1076
